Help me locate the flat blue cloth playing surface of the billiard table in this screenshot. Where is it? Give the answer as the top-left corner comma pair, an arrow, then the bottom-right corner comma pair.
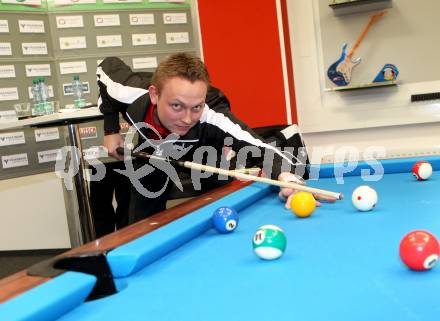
55,164 -> 440,321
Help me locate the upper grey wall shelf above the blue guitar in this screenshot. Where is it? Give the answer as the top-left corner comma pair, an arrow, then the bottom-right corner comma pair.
329,0 -> 393,16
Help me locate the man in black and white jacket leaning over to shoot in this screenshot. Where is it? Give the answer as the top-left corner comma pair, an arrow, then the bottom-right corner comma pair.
97,53 -> 312,223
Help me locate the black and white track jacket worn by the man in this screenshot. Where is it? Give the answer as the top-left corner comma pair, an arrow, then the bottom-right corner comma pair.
97,57 -> 302,179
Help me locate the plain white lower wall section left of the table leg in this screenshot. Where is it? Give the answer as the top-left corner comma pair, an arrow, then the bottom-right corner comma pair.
0,173 -> 70,251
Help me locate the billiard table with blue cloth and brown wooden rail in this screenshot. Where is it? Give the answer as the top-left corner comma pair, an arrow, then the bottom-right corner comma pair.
0,156 -> 440,321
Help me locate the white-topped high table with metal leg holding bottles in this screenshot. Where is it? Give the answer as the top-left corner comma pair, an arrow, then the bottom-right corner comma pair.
0,107 -> 103,245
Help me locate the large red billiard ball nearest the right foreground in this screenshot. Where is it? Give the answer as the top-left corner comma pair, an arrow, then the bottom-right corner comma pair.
399,230 -> 439,271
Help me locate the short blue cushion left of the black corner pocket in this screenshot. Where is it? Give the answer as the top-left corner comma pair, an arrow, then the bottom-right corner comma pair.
0,272 -> 96,321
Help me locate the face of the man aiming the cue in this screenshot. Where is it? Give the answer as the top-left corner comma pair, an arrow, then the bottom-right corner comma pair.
148,77 -> 208,136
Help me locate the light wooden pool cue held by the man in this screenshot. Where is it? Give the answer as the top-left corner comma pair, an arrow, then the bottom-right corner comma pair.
116,147 -> 344,200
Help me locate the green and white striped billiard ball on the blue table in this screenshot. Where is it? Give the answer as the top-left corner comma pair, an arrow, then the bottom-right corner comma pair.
252,225 -> 287,260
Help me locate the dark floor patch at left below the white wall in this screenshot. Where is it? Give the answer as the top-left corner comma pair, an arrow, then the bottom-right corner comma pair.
0,249 -> 68,279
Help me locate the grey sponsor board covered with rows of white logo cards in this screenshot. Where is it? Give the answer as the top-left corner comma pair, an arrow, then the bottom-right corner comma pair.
0,0 -> 196,179
